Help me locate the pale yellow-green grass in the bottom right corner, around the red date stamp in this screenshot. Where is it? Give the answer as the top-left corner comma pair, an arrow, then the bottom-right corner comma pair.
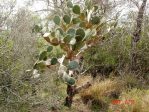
109,89 -> 149,112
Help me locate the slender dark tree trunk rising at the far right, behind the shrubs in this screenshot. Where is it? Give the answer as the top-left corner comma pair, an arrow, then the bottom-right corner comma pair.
131,0 -> 147,71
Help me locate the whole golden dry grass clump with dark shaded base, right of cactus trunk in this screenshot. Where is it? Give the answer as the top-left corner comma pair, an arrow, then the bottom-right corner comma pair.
80,79 -> 124,112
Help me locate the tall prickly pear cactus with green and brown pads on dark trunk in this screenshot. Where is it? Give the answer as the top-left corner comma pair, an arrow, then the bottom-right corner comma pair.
33,0 -> 106,107
